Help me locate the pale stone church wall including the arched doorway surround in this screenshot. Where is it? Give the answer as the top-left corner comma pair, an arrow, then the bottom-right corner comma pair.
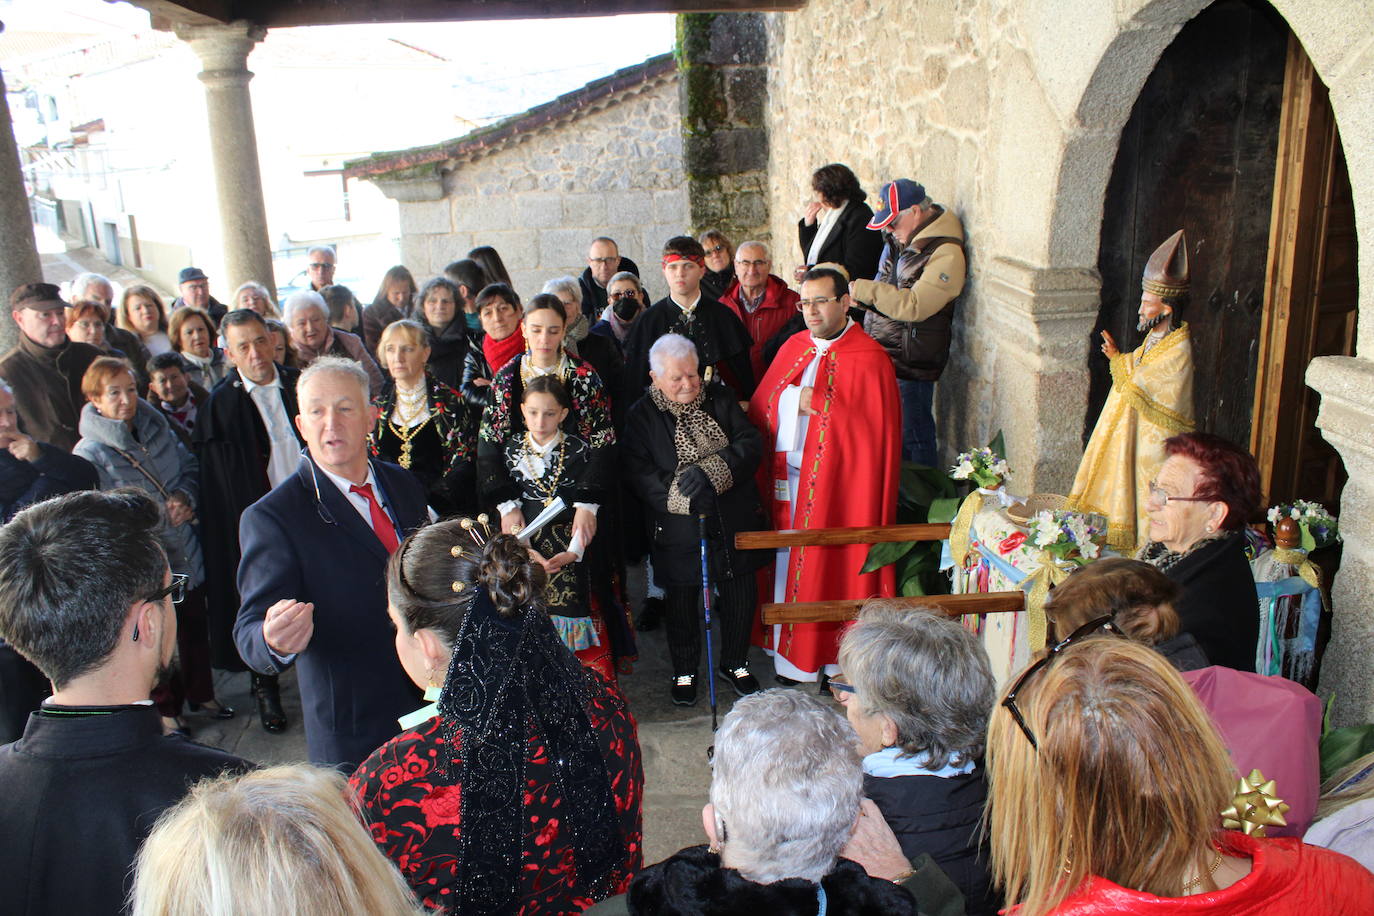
768,0 -> 1374,724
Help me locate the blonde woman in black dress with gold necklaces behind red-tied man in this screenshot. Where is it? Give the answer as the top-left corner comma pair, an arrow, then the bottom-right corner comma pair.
372,319 -> 477,518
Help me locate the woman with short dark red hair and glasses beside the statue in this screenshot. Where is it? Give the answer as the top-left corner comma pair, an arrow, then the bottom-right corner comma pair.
1140,433 -> 1260,672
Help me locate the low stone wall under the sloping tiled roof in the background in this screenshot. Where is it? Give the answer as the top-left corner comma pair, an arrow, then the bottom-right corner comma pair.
390,74 -> 690,297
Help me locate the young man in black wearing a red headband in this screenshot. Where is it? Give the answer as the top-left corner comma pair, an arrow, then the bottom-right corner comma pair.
624,235 -> 754,404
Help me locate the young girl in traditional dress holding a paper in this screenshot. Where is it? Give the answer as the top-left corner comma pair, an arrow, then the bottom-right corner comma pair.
497,375 -> 614,680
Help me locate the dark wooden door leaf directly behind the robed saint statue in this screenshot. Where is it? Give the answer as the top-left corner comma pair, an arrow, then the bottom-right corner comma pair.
1084,0 -> 1289,444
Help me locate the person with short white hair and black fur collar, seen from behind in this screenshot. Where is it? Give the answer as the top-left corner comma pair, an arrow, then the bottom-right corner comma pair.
588,689 -> 952,916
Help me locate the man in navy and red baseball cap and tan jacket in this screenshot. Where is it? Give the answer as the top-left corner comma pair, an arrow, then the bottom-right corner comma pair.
849,179 -> 966,467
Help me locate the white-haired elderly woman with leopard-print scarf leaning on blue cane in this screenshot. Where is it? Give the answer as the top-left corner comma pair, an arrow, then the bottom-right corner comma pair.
621,334 -> 769,706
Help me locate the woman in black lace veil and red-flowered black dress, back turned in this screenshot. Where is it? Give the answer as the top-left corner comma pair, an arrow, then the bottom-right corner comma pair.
352,519 -> 644,916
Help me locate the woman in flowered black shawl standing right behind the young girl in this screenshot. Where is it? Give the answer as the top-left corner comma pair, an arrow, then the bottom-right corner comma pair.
477,293 -> 616,554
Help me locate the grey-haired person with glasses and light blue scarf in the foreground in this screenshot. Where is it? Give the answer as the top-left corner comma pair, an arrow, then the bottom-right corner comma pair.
830,599 -> 999,916
